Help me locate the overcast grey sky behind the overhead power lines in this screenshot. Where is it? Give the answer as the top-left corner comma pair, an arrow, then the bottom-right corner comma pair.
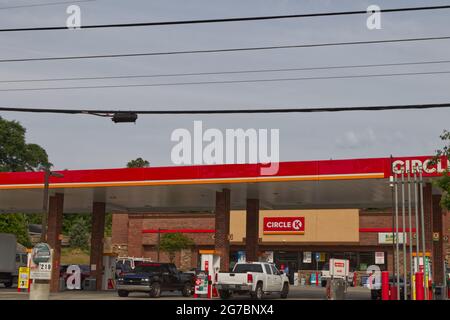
0,0 -> 450,169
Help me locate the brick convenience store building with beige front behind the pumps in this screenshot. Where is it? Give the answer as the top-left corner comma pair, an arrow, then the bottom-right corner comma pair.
112,198 -> 450,279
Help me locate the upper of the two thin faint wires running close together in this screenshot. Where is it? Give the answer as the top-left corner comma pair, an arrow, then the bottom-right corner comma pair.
0,60 -> 450,83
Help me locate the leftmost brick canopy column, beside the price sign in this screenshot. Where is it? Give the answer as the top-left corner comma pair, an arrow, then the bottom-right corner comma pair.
47,193 -> 64,292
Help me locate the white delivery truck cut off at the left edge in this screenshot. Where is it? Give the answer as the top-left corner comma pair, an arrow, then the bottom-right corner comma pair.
0,233 -> 26,288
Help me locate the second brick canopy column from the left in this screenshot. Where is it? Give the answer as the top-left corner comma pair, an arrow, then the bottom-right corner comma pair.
90,202 -> 106,291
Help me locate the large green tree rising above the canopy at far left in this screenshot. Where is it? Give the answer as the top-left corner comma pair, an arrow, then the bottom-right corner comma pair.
0,117 -> 51,171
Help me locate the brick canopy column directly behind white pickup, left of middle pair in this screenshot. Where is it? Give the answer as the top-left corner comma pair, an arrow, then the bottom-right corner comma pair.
214,189 -> 230,272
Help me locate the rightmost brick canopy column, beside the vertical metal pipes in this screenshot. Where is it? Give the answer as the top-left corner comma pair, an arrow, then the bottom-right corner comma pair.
432,195 -> 445,285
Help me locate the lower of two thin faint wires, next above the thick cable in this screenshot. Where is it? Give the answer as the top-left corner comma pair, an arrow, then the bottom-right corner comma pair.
0,71 -> 450,92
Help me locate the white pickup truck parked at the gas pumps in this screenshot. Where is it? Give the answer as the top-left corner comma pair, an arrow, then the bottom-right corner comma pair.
216,262 -> 289,299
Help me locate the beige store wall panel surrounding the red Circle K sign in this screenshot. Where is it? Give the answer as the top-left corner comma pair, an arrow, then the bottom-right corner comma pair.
230,209 -> 359,244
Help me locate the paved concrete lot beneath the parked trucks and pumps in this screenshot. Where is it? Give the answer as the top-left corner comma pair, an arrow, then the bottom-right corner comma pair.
0,287 -> 370,301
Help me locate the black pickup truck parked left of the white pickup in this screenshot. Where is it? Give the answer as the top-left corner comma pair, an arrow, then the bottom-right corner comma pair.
117,262 -> 195,298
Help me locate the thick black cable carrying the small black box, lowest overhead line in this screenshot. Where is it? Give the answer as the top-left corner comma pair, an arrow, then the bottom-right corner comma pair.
0,103 -> 450,116
